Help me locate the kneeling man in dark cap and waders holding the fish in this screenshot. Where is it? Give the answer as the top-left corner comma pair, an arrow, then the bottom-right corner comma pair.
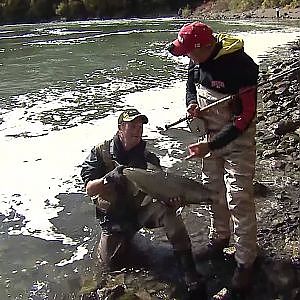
81,109 -> 206,299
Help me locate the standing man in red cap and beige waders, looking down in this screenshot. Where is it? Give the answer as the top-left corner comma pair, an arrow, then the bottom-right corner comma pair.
168,22 -> 258,292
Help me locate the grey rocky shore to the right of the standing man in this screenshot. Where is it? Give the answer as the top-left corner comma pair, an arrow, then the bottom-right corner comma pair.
256,38 -> 300,264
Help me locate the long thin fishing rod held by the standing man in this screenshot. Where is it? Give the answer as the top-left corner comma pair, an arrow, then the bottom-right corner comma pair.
165,62 -> 300,130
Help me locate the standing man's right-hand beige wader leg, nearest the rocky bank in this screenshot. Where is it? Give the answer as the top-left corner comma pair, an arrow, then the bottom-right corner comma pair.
225,145 -> 257,266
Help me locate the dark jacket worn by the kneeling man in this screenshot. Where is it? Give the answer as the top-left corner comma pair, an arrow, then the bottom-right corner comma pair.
81,135 -> 160,232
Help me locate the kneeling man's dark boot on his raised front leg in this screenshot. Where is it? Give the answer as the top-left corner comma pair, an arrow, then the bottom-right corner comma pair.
174,250 -> 207,300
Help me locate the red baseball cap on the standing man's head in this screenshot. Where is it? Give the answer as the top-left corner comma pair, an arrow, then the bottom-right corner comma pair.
168,21 -> 214,56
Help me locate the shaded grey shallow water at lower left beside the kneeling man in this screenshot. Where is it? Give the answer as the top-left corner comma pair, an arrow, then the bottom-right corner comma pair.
0,193 -> 97,299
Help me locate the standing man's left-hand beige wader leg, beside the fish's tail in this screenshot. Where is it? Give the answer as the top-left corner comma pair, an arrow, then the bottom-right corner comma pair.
202,155 -> 230,240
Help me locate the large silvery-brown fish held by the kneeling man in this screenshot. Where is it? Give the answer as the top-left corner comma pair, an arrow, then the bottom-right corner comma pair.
122,167 -> 212,206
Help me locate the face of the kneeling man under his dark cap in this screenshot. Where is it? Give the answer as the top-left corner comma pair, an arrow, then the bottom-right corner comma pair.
119,117 -> 144,150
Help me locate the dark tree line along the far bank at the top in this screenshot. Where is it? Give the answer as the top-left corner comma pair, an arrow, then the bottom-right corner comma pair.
0,0 -> 300,24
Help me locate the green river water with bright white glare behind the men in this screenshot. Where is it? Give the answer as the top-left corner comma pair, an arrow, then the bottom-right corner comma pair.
0,19 -> 300,300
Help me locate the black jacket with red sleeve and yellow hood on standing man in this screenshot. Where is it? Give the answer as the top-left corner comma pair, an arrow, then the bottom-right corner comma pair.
186,34 -> 258,150
